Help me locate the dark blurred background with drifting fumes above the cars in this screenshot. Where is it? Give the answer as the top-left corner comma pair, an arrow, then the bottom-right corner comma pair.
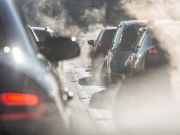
16,0 -> 131,34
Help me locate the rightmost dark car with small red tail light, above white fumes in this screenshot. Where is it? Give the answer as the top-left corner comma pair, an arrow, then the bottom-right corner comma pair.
125,28 -> 169,76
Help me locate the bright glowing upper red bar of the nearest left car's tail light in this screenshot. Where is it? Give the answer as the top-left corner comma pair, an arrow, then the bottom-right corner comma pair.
0,93 -> 39,106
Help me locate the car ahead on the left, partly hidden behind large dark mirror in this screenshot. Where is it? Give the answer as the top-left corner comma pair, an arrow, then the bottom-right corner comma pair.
28,25 -> 73,101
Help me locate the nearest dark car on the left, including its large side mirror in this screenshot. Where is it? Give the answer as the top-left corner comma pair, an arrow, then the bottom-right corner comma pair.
0,0 -> 80,135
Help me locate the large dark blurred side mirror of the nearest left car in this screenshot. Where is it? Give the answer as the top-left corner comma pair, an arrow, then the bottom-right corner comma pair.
37,37 -> 80,62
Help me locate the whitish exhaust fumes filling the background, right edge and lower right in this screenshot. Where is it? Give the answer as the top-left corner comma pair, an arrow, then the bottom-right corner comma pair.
17,0 -> 180,135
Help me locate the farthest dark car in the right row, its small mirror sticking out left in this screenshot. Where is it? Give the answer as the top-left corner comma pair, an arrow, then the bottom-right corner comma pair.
88,27 -> 117,71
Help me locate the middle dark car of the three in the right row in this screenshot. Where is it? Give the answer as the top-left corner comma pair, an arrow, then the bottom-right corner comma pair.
101,20 -> 146,83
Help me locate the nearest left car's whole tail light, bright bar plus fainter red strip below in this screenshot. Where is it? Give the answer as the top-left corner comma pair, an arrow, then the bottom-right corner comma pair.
0,93 -> 43,120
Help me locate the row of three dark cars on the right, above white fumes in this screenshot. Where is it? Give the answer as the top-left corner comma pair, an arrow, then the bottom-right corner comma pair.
88,20 -> 170,83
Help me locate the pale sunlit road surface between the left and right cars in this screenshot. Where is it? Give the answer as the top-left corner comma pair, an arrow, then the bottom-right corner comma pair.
61,59 -> 119,135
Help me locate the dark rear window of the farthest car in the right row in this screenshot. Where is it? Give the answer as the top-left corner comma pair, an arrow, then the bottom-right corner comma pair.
100,29 -> 116,41
